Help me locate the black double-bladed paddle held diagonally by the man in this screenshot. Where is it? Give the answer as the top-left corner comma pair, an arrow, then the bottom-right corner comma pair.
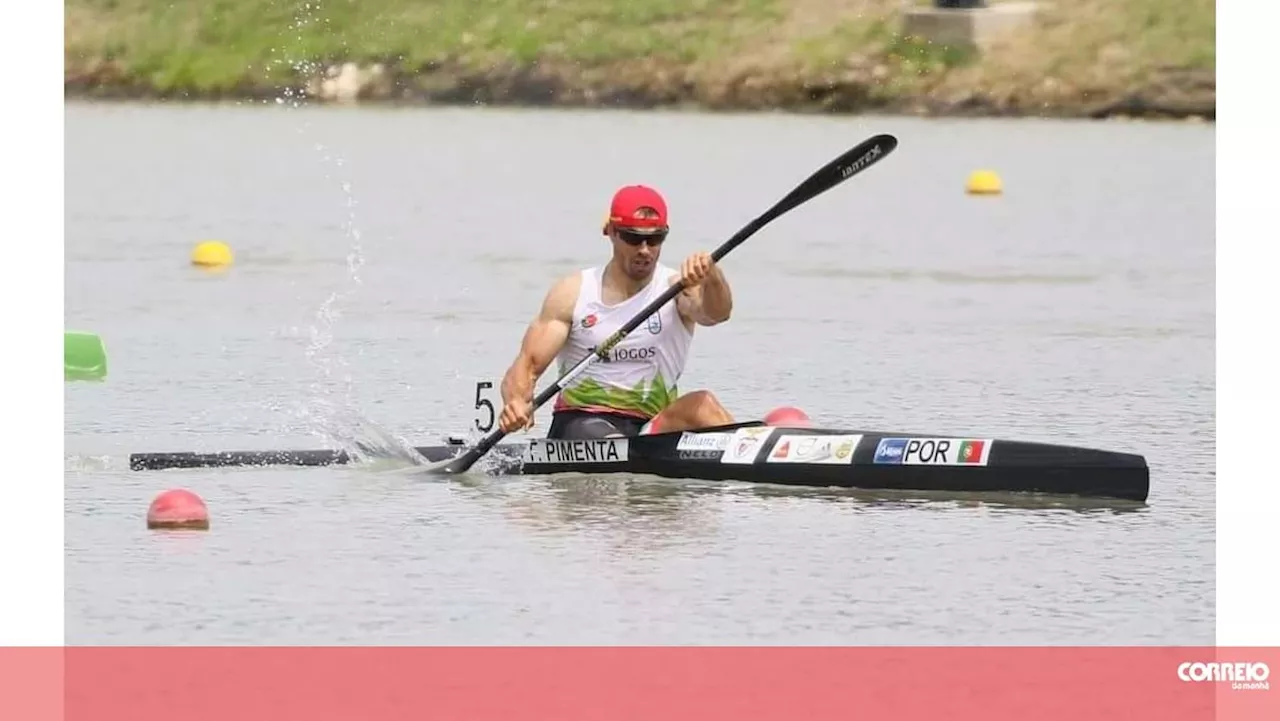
428,134 -> 897,474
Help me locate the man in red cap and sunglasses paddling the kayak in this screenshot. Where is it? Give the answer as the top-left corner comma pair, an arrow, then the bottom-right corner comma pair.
499,186 -> 733,438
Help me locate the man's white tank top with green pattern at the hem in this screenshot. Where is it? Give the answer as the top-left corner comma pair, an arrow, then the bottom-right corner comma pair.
556,265 -> 694,419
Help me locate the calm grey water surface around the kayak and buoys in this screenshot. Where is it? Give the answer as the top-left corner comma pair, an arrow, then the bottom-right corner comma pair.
65,104 -> 1215,644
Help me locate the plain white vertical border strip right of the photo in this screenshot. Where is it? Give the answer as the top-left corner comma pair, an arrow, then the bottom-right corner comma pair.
1213,3 -> 1280,647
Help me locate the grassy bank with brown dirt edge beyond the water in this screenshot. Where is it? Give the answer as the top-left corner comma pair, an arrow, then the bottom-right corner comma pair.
64,0 -> 1216,115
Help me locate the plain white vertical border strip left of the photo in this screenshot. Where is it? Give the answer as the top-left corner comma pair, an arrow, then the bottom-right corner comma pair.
0,3 -> 65,645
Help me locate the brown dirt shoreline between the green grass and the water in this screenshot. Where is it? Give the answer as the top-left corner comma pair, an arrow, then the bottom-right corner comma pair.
64,61 -> 1216,120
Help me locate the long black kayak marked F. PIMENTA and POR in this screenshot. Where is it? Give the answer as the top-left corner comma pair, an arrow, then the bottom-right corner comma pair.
129,421 -> 1149,501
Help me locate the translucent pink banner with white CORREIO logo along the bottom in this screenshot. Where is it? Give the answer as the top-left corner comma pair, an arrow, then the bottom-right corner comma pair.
0,647 -> 1280,721
